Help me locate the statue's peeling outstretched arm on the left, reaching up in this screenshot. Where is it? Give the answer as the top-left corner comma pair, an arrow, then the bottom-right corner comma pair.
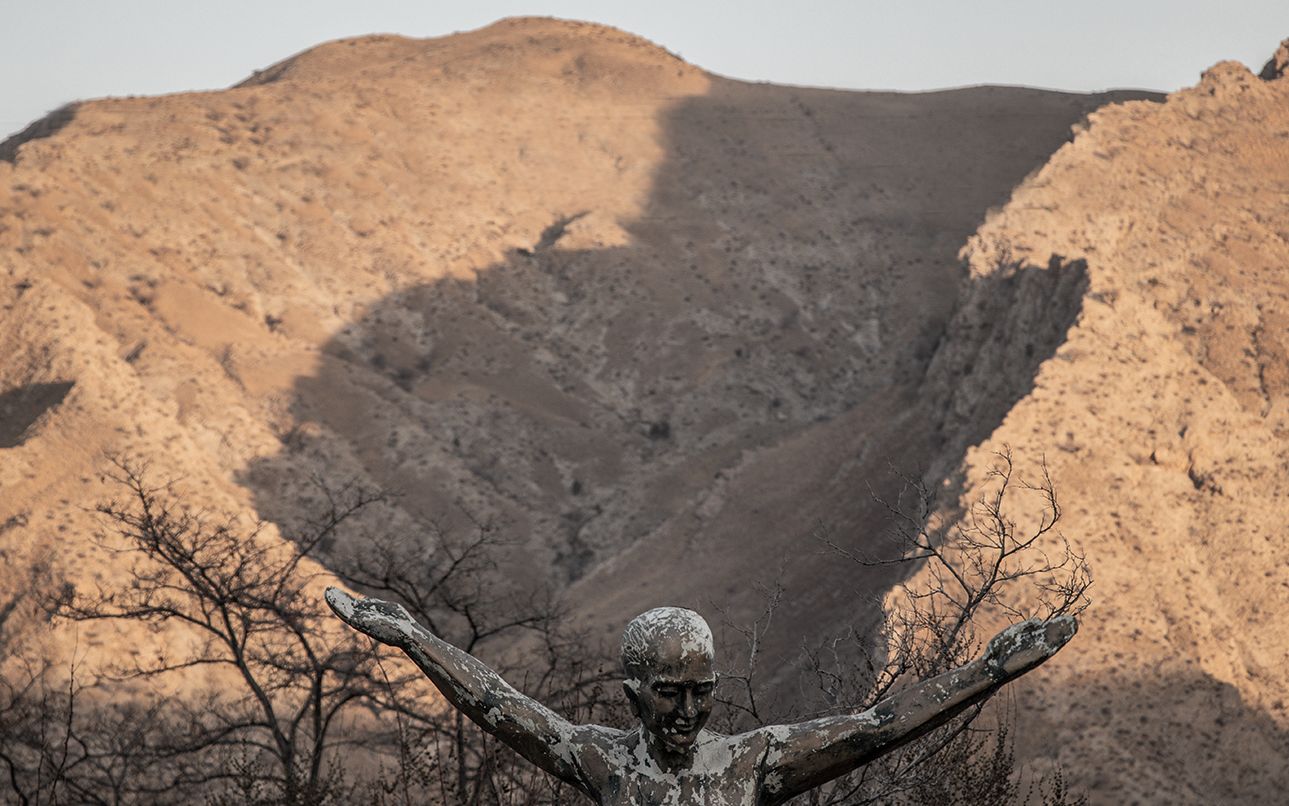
326,588 -> 594,797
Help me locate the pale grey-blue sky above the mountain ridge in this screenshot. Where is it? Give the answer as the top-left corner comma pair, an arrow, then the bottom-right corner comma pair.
0,0 -> 1289,139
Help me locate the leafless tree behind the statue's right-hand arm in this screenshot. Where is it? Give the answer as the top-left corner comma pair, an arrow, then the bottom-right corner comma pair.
723,449 -> 1092,806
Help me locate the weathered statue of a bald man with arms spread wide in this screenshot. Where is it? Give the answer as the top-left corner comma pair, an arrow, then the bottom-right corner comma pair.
326,588 -> 1078,806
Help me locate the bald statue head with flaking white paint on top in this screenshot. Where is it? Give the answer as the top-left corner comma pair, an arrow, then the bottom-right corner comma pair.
623,607 -> 717,753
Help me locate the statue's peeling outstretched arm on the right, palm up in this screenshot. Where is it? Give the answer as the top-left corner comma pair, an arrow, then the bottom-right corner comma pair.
763,616 -> 1078,803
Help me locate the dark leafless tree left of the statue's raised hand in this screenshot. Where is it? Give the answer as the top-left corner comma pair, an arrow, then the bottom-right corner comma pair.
54,459 -> 394,803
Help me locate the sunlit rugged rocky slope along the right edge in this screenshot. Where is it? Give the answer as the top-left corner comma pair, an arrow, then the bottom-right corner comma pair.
907,48 -> 1289,803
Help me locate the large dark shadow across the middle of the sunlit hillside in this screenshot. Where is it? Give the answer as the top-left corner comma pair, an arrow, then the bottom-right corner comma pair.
242,83 -> 1134,663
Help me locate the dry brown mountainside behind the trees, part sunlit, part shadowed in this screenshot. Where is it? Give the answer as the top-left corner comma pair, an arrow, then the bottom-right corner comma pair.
0,19 -> 1289,803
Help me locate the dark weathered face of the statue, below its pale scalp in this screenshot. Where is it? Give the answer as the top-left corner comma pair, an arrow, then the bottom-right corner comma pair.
629,636 -> 717,753
